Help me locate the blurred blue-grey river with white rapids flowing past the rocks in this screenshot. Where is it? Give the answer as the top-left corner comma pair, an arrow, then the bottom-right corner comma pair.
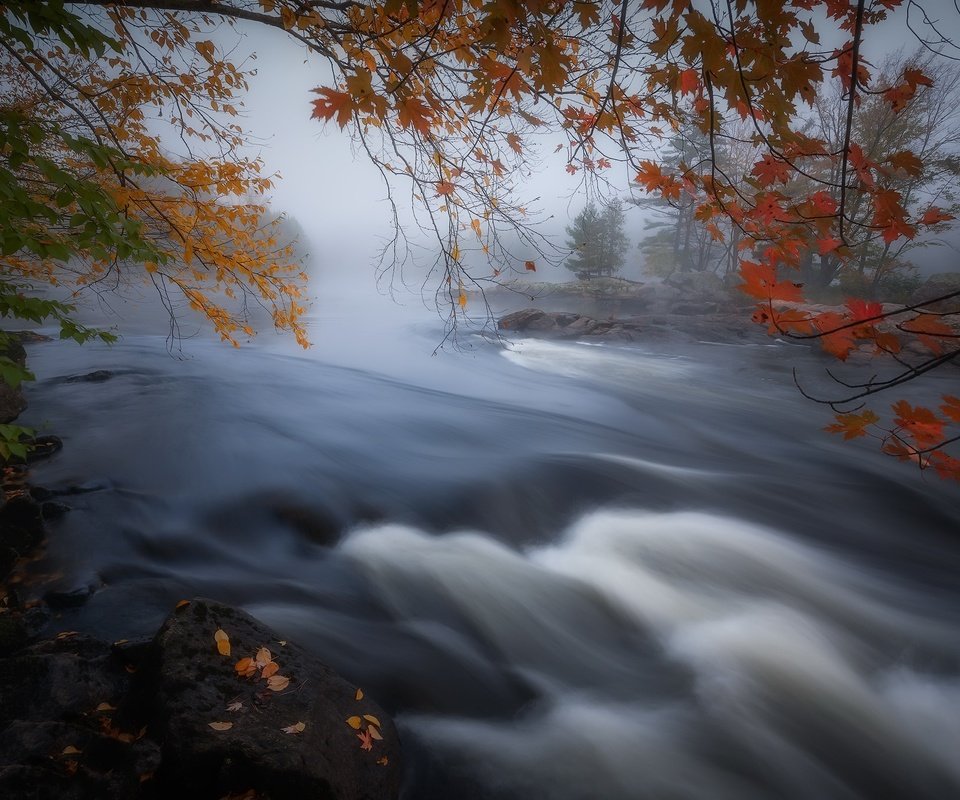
15,298 -> 960,800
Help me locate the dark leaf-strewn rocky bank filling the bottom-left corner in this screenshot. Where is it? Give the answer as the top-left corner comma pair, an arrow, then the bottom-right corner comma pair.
0,599 -> 402,800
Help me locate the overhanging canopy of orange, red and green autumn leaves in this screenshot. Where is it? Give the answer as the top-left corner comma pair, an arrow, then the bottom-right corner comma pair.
0,0 -> 960,478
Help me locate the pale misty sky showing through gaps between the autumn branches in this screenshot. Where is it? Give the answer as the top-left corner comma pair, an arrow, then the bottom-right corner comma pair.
214,0 -> 960,296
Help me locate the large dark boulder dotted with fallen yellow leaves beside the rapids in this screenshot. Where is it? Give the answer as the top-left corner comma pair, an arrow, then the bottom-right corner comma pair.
151,600 -> 401,800
